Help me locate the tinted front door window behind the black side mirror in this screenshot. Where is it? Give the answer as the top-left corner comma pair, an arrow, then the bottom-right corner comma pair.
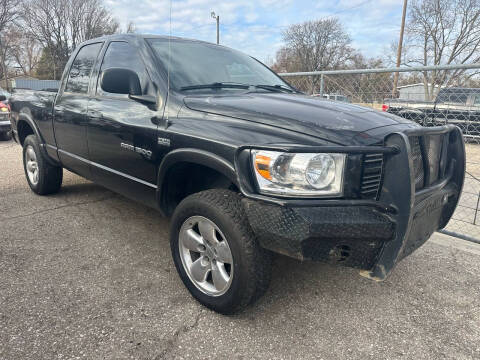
97,41 -> 148,94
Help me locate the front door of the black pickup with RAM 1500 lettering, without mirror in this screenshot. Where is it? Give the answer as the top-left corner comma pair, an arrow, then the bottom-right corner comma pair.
87,41 -> 159,205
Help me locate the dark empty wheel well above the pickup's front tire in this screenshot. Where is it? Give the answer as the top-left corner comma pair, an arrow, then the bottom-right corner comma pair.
160,162 -> 239,216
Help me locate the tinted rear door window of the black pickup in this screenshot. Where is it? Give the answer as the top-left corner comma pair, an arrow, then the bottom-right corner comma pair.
65,43 -> 102,94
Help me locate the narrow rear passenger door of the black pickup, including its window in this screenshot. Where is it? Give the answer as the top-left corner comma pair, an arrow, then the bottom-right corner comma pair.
54,42 -> 102,178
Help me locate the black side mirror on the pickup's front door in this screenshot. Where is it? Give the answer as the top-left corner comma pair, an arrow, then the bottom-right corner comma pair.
100,68 -> 142,95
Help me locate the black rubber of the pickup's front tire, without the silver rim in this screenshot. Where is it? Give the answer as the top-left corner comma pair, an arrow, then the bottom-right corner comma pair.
170,189 -> 272,314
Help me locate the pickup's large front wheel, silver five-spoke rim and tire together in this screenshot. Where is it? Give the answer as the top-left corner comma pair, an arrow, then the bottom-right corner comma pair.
170,190 -> 271,314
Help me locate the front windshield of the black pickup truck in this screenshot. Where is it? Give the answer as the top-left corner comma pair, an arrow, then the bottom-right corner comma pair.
147,39 -> 292,91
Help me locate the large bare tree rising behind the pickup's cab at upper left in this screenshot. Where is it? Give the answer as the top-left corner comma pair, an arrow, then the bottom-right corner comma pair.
22,0 -> 119,78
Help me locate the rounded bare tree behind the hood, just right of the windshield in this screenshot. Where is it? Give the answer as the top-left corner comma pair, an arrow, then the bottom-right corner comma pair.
277,18 -> 353,90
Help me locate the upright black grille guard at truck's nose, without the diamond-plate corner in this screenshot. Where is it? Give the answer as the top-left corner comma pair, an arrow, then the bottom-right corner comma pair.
361,125 -> 465,280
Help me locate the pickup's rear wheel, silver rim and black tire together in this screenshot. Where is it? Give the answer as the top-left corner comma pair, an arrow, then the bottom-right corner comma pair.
23,135 -> 63,195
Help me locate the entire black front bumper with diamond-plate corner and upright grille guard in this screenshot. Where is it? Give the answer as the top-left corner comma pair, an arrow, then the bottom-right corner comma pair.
243,126 -> 465,280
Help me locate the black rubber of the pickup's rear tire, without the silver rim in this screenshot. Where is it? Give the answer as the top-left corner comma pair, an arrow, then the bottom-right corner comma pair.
23,135 -> 63,195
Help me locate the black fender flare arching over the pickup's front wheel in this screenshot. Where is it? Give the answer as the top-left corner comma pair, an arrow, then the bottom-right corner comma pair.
157,148 -> 239,211
